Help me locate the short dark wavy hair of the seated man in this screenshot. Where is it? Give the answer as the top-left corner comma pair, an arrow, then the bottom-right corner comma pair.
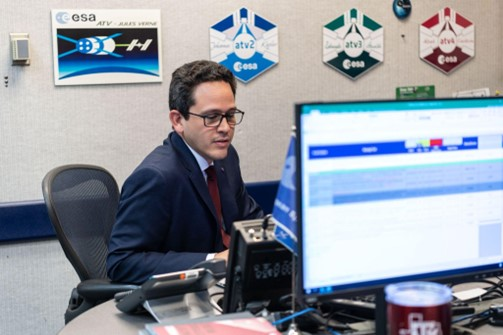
169,60 -> 236,119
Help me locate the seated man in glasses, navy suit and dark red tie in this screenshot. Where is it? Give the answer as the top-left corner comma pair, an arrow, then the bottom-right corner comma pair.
107,60 -> 263,284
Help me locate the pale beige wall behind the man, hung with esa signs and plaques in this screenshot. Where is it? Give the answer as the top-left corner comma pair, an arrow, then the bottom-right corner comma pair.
0,0 -> 503,334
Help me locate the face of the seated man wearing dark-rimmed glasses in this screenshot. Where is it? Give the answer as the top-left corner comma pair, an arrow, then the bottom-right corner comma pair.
170,81 -> 236,163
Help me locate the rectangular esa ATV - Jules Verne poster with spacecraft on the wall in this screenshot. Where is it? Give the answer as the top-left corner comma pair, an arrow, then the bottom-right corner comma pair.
51,9 -> 162,85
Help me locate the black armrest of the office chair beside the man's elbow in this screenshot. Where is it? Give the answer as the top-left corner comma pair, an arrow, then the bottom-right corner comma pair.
77,279 -> 138,301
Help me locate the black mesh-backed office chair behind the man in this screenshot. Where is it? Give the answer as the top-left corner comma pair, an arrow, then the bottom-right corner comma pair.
42,164 -> 137,323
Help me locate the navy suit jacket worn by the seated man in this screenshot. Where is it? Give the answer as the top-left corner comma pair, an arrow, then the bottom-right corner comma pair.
107,132 -> 263,284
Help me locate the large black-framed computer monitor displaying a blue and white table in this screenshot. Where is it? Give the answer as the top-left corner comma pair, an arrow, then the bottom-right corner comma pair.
296,97 -> 503,301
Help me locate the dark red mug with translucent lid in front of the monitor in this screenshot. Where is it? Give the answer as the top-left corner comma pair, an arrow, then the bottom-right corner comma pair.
384,281 -> 452,335
